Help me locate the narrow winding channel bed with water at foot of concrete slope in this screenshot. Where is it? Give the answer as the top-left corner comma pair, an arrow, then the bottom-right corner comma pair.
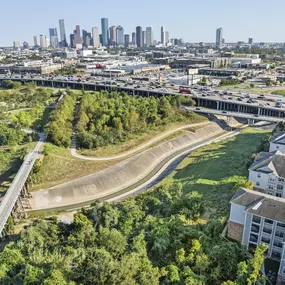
28,127 -> 240,215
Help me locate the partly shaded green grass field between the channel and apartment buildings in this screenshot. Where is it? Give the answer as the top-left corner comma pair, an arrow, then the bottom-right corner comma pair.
159,128 -> 268,221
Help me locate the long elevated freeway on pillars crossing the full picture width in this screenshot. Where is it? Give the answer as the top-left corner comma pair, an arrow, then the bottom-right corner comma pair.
0,77 -> 285,120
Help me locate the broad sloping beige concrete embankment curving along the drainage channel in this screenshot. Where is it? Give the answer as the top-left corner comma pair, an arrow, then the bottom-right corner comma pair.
30,123 -> 223,211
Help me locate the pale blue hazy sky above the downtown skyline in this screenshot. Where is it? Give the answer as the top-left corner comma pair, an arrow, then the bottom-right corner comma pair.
0,0 -> 285,46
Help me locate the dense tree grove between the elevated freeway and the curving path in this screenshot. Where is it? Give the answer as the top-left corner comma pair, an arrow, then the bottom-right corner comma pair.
78,92 -> 193,148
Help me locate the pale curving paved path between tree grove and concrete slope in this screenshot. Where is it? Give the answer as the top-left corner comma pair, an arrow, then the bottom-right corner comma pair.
70,122 -> 210,161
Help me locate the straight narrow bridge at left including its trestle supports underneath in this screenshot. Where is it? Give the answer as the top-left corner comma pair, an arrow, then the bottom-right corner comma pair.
0,134 -> 45,237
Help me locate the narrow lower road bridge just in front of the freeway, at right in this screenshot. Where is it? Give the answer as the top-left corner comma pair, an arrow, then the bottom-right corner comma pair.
185,107 -> 284,123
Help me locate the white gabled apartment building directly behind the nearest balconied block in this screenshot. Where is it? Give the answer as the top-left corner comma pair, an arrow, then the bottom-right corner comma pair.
248,150 -> 285,198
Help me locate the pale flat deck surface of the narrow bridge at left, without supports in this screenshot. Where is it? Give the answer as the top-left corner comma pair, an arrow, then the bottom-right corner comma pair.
0,134 -> 44,235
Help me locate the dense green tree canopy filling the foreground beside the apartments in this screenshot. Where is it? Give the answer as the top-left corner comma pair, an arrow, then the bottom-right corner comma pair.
0,181 -> 265,285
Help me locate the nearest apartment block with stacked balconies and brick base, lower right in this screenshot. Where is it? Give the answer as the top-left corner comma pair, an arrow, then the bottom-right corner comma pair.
228,188 -> 285,284
